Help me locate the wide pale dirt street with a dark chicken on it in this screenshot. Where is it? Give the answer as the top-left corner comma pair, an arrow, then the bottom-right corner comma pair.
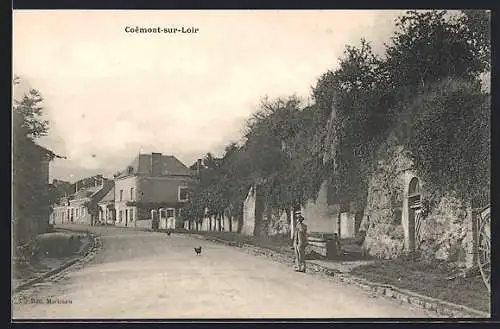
13,227 -> 429,319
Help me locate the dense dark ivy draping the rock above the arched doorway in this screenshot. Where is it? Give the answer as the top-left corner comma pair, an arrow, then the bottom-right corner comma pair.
406,80 -> 491,200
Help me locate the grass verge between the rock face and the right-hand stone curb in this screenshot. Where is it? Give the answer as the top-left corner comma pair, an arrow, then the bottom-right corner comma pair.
351,260 -> 490,312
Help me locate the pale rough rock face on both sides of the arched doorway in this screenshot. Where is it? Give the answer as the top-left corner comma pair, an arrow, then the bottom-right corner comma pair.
360,138 -> 473,265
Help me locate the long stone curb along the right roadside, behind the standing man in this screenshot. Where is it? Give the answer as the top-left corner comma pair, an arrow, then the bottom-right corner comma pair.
191,234 -> 491,318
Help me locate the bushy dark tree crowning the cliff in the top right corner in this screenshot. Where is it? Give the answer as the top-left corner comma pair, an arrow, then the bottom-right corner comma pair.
384,10 -> 489,87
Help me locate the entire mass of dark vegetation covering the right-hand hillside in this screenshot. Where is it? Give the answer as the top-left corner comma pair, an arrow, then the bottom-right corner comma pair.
187,10 -> 490,233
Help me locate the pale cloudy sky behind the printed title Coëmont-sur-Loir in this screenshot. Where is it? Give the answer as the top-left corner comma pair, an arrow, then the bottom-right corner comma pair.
13,10 -> 403,182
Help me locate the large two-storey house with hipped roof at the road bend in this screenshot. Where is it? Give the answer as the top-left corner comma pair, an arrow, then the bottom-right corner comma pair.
115,153 -> 197,228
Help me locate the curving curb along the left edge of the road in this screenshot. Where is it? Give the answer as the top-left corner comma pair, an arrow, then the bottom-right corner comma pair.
13,229 -> 102,293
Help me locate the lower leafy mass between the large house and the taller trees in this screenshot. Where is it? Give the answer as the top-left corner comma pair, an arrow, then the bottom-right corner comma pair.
185,96 -> 328,222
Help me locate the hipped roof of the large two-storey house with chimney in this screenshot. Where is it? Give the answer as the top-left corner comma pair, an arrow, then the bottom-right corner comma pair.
116,154 -> 195,178
